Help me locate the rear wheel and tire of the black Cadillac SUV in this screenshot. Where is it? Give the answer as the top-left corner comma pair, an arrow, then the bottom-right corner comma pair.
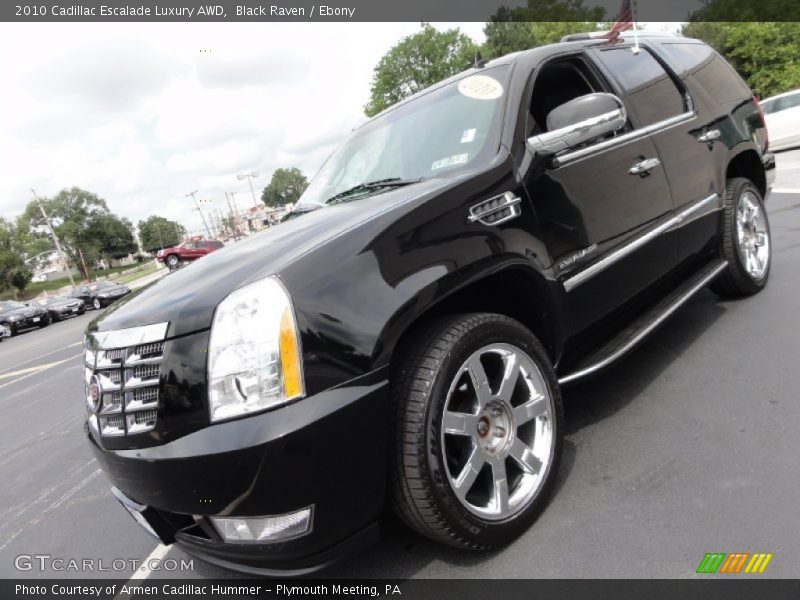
710,177 -> 772,296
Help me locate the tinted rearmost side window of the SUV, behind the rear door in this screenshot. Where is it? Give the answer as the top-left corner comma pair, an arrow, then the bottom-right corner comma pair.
661,42 -> 753,104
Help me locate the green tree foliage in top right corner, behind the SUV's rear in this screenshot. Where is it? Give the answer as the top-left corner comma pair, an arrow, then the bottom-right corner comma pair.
683,21 -> 800,98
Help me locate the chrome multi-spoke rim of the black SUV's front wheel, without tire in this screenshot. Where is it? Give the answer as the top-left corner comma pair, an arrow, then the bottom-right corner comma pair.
441,344 -> 554,521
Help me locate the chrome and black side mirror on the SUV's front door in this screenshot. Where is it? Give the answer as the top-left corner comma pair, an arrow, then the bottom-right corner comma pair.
528,93 -> 628,155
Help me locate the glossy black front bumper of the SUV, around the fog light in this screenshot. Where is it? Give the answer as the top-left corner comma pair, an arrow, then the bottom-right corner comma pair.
87,374 -> 389,575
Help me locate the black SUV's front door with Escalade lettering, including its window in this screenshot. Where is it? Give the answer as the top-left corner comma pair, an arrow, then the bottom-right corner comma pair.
525,54 -> 676,333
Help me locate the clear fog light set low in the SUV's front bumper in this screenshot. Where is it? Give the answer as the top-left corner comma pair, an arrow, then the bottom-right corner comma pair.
211,506 -> 313,542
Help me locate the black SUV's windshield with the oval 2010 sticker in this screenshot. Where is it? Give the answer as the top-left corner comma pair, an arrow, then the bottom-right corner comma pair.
296,66 -> 508,210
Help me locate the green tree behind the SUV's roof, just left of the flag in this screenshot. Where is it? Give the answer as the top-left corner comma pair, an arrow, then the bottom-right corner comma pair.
483,0 -> 606,58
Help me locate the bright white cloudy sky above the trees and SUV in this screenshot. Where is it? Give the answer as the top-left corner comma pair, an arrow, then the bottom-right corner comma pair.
0,23 -> 483,231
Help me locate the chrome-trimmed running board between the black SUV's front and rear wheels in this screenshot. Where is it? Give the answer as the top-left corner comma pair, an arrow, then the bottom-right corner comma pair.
558,259 -> 728,385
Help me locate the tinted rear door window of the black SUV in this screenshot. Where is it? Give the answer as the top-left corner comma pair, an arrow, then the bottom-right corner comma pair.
596,48 -> 686,126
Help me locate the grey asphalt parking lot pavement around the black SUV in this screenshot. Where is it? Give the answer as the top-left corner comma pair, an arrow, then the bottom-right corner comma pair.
0,151 -> 800,578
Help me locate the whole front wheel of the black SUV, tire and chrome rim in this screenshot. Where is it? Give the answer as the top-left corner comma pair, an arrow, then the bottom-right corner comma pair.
391,313 -> 564,550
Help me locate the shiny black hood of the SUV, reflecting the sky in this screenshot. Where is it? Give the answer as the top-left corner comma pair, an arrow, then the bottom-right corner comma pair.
90,178 -> 461,337
